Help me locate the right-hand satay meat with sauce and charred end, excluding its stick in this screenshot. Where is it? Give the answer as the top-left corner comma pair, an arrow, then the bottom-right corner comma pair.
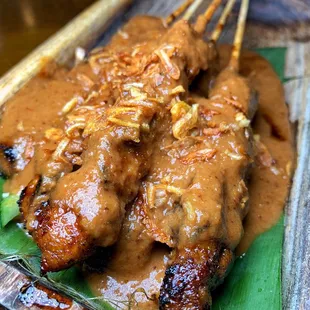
159,70 -> 253,309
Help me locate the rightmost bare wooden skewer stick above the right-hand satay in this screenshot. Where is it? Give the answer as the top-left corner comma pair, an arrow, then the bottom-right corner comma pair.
229,0 -> 249,71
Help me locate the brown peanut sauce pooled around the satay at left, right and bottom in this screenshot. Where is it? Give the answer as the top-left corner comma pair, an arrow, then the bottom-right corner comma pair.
0,21 -> 293,309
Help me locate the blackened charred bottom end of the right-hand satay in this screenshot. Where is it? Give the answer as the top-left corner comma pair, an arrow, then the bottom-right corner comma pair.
159,241 -> 233,310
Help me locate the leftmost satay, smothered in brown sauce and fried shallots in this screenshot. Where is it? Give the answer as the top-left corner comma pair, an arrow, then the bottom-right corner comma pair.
0,16 -> 166,193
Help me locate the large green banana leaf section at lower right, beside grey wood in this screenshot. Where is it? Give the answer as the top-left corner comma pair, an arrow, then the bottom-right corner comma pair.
212,217 -> 284,310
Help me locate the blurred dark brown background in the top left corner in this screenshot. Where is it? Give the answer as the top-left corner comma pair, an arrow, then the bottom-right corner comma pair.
0,0 -> 95,76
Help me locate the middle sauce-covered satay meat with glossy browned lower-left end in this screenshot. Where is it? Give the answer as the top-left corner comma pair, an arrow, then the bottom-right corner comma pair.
21,21 -> 212,271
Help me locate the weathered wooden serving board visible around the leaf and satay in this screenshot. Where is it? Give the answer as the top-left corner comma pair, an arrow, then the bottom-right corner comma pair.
0,0 -> 310,310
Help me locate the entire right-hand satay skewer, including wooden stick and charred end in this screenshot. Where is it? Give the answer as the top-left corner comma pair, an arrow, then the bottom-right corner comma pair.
159,0 -> 253,309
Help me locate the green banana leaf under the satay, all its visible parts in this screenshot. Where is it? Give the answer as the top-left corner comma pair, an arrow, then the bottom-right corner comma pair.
0,48 -> 286,310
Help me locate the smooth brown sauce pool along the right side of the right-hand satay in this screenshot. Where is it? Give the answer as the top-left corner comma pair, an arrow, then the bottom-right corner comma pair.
236,49 -> 294,254
